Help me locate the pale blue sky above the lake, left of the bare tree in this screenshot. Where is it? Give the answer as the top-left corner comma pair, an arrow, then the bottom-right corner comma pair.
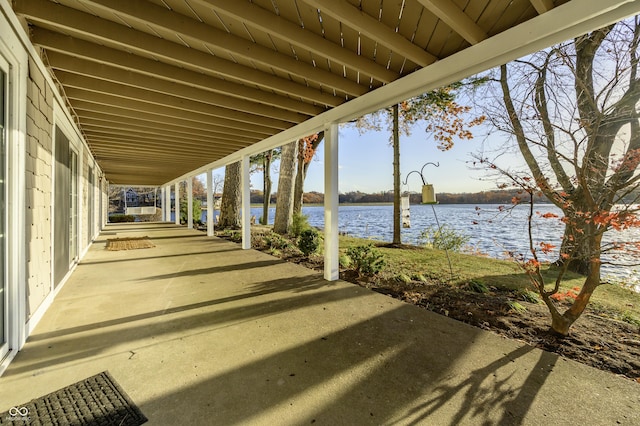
210,120 -> 520,193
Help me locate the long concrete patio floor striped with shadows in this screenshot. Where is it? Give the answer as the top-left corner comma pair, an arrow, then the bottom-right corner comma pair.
0,223 -> 640,425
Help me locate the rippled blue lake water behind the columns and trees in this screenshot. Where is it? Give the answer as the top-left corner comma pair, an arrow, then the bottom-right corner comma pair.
198,204 -> 640,291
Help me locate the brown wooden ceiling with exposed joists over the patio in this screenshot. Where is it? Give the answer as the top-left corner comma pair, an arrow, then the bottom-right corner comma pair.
8,0 -> 596,185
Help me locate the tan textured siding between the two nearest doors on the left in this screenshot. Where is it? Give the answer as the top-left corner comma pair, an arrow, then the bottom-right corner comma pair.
25,57 -> 54,318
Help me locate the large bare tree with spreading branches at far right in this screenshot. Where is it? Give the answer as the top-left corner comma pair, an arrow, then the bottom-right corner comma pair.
480,17 -> 640,335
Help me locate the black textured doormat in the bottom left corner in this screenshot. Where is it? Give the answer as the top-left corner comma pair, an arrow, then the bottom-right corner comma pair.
0,371 -> 147,426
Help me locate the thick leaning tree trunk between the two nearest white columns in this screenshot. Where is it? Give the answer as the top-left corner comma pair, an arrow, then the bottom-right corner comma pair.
273,141 -> 298,234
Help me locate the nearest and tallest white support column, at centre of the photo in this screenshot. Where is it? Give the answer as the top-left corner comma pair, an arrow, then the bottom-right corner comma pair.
324,123 -> 340,281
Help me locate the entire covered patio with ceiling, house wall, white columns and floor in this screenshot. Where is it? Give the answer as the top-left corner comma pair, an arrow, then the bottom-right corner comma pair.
0,0 -> 640,425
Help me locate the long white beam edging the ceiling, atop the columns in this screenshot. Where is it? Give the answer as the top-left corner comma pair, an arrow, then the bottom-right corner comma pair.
158,0 -> 640,184
